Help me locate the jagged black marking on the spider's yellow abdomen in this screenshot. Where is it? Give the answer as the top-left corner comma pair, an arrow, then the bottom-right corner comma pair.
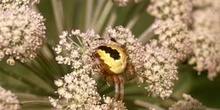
98,46 -> 120,60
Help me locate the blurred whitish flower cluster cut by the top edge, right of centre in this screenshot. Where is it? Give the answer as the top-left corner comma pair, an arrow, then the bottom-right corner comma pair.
147,0 -> 192,23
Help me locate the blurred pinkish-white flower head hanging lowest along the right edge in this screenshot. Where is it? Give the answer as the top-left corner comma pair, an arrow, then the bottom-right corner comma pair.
189,29 -> 220,80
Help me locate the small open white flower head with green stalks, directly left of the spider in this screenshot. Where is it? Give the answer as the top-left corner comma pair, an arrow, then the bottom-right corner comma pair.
54,30 -> 98,71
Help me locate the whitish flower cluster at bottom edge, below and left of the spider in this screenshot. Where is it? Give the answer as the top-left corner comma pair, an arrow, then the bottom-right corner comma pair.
49,69 -> 101,110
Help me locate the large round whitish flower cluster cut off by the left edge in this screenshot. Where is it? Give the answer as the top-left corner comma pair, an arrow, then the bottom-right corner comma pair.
0,1 -> 45,65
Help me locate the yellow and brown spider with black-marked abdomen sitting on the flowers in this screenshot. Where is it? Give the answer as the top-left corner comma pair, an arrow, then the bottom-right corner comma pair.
92,38 -> 136,100
